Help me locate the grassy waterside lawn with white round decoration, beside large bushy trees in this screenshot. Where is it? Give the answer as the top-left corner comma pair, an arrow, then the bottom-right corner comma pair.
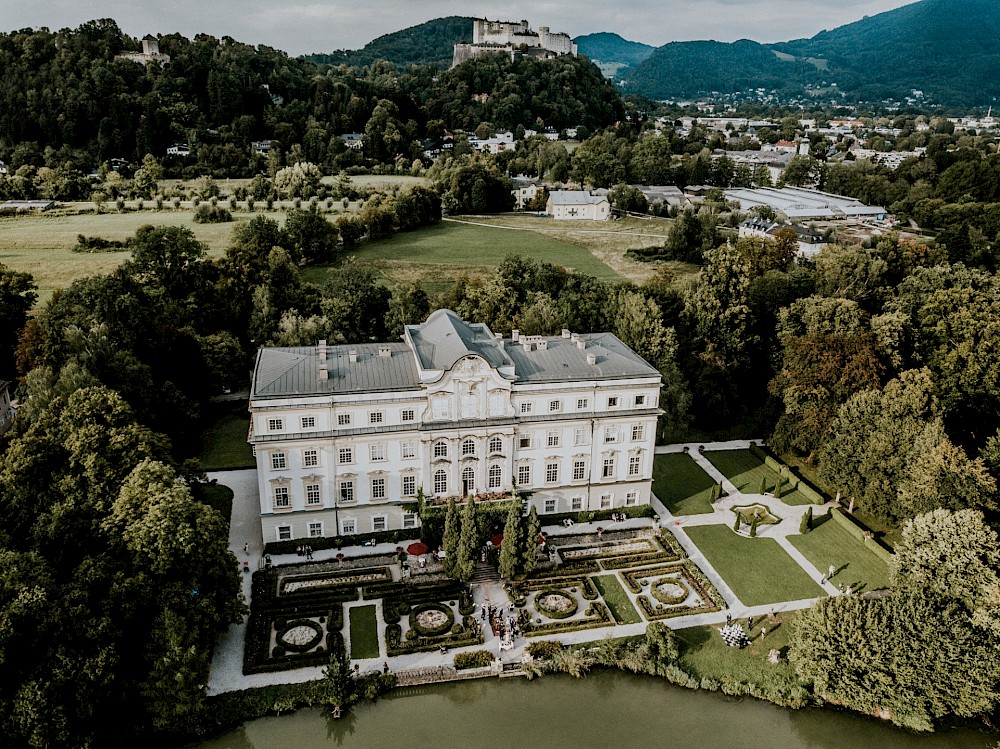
676,612 -> 800,693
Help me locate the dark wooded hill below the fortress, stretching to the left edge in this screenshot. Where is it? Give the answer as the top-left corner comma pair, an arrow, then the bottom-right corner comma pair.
0,19 -> 624,172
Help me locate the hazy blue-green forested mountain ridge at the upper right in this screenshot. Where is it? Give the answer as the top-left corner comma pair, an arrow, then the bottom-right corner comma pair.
624,0 -> 1000,106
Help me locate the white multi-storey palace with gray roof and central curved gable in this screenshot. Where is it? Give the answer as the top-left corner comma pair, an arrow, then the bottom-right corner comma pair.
250,310 -> 661,542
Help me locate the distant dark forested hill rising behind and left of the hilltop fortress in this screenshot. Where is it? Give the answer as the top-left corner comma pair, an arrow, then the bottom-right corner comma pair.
306,16 -> 472,69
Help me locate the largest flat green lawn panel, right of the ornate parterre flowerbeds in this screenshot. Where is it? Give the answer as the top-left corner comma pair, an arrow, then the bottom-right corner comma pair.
684,521 -> 826,606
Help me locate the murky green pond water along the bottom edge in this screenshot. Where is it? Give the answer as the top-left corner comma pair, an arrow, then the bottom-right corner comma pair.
199,672 -> 996,749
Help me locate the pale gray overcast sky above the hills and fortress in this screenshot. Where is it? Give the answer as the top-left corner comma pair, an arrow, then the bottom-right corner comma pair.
0,0 -> 913,55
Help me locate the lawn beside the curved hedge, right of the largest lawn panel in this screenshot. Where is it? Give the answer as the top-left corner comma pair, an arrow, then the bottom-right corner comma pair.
788,515 -> 889,592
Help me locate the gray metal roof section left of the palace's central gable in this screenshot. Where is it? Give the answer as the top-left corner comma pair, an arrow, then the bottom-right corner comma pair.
250,343 -> 420,398
